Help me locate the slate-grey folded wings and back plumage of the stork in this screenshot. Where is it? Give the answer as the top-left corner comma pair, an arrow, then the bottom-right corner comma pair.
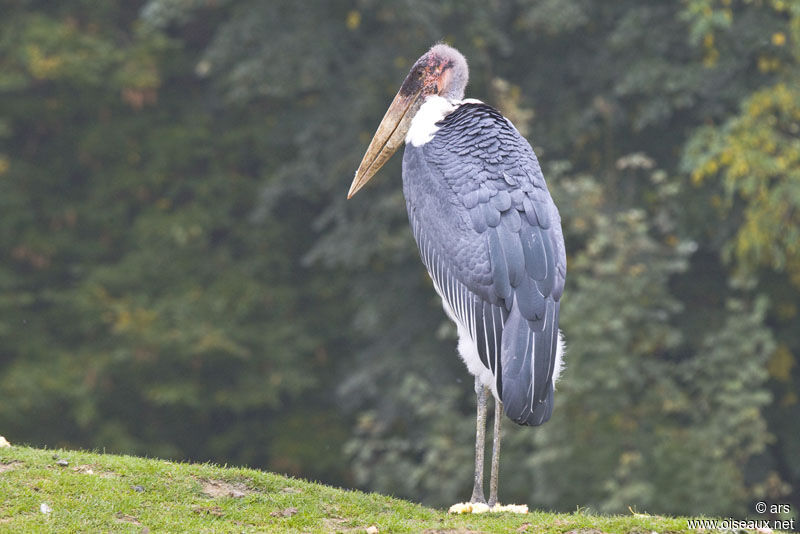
403,105 -> 566,425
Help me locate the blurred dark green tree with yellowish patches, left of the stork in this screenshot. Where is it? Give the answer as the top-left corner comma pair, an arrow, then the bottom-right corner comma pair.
0,1 -> 347,481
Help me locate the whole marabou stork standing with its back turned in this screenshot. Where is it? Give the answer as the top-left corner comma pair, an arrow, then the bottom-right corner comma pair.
347,44 -> 567,507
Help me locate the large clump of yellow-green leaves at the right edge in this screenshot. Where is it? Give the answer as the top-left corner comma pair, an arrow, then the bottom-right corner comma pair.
687,83 -> 800,286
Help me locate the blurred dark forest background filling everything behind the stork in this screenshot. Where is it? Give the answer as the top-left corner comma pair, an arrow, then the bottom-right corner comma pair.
0,0 -> 800,517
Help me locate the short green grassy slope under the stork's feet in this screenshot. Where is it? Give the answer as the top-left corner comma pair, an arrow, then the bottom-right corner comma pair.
0,447 -> 700,534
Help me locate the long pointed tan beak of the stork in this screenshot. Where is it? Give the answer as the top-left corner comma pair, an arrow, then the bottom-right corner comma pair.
347,90 -> 422,198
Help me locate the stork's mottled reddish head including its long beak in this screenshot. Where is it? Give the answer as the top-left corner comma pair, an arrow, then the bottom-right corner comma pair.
347,44 -> 469,198
